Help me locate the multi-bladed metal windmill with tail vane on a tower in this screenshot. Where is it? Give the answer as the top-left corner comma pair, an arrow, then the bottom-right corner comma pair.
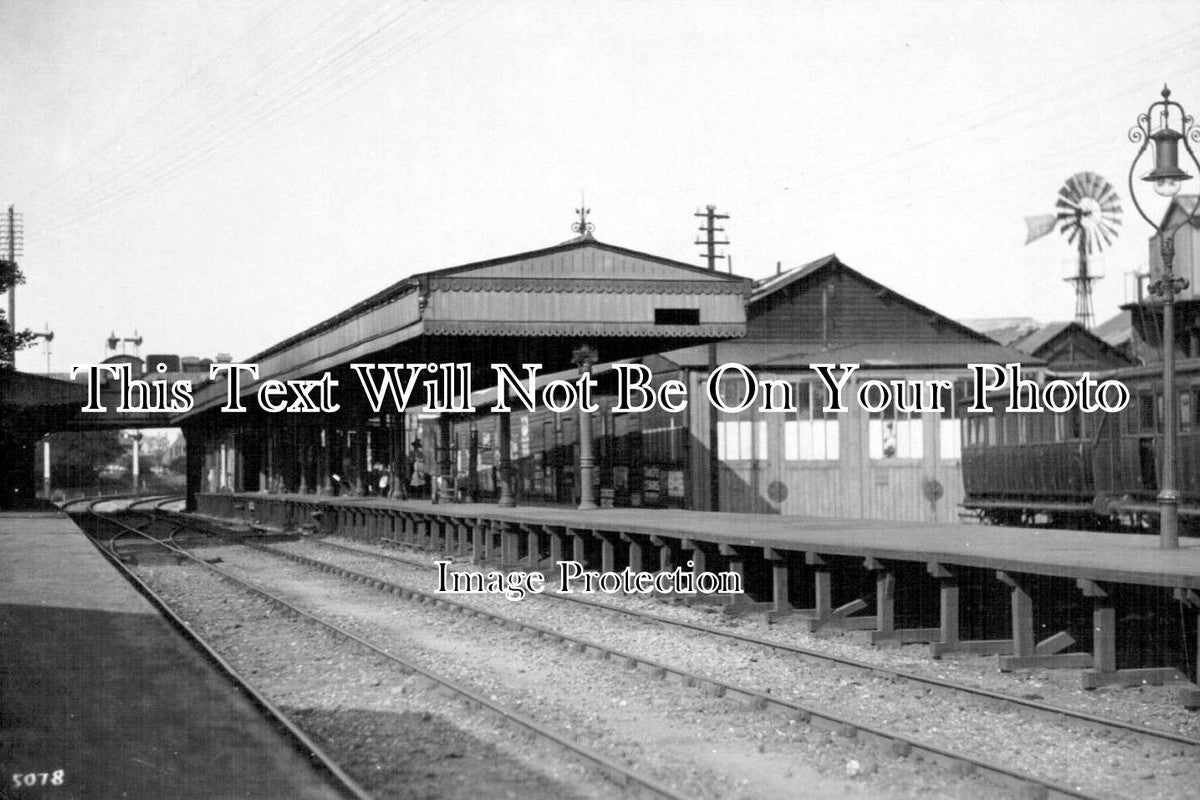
1025,173 -> 1121,330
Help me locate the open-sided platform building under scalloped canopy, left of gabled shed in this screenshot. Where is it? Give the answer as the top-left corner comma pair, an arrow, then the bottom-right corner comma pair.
175,234 -> 752,510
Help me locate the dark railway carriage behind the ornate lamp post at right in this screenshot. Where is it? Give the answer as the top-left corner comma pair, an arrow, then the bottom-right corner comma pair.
962,359 -> 1200,535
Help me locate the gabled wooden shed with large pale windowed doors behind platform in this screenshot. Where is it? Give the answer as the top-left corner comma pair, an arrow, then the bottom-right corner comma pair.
446,255 -> 1043,522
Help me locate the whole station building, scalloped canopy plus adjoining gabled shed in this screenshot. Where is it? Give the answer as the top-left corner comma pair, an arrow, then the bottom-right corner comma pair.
176,224 -> 1056,521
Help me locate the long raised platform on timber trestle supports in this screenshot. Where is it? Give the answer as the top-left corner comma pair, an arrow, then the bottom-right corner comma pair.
198,493 -> 1200,708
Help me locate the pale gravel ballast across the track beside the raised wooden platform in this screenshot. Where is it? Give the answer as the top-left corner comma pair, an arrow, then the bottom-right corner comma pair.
262,542 -> 1200,798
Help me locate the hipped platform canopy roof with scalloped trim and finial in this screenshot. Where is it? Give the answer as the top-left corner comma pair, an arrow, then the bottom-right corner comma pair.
176,236 -> 752,421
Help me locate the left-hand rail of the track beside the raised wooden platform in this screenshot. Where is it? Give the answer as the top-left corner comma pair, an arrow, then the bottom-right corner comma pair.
244,542 -> 1096,800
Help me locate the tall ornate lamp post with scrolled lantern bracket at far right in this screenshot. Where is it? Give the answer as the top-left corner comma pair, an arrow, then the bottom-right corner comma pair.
1129,86 -> 1200,549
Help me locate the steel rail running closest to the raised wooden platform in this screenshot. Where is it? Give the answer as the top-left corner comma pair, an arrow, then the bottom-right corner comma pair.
306,539 -> 1200,748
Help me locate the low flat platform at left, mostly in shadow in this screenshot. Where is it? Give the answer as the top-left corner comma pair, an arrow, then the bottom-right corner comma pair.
0,513 -> 347,800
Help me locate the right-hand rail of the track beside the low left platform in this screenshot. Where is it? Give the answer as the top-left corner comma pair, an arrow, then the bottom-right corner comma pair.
84,511 -> 685,800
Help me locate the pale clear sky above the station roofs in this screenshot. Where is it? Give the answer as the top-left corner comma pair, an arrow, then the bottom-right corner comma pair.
0,0 -> 1200,372
